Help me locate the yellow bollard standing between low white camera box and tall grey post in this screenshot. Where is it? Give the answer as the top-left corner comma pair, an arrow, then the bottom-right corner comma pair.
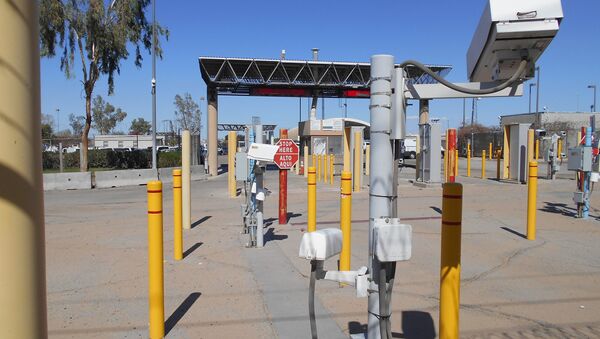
340,172 -> 352,271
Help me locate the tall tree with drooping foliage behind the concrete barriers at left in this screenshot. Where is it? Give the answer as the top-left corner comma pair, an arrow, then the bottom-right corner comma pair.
40,0 -> 168,171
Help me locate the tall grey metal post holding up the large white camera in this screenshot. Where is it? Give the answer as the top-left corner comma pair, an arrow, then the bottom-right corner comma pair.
367,55 -> 394,339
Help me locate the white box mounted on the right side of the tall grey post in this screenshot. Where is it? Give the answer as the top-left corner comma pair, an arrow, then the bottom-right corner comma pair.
373,218 -> 412,262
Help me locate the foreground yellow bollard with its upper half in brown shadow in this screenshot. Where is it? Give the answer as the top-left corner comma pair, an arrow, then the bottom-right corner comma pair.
439,183 -> 463,339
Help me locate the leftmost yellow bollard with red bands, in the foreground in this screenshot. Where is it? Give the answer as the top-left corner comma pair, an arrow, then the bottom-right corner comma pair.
146,181 -> 165,339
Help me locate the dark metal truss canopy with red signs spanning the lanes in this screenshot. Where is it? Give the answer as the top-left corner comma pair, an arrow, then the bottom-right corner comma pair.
199,57 -> 452,98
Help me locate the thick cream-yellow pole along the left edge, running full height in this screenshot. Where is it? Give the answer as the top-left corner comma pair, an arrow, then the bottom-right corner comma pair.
0,0 -> 48,338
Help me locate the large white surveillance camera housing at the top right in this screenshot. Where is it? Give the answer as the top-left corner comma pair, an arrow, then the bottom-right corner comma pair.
467,0 -> 563,82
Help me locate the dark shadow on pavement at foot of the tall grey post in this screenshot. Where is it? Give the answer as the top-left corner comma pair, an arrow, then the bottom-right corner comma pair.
348,311 -> 436,339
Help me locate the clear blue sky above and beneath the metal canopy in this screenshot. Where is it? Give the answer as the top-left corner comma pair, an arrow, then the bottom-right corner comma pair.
41,0 -> 600,137
